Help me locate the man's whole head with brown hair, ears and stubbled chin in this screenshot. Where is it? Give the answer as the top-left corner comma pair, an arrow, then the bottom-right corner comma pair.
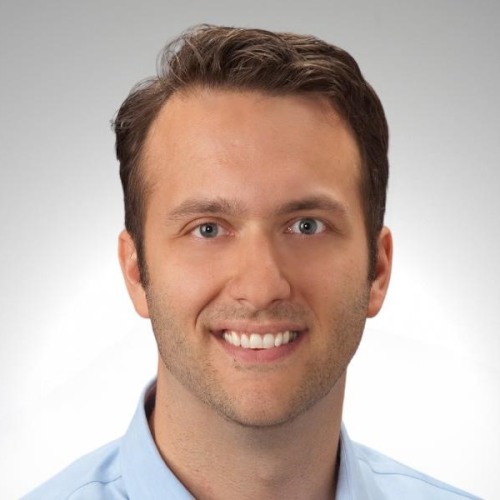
116,27 -> 392,427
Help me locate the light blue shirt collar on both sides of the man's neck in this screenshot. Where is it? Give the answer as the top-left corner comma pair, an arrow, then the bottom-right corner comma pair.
120,381 -> 381,500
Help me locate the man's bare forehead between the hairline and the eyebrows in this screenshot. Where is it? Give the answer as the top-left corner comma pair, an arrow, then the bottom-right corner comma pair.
143,89 -> 360,213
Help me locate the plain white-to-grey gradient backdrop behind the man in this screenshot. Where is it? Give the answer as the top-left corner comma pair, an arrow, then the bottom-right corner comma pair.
0,0 -> 500,499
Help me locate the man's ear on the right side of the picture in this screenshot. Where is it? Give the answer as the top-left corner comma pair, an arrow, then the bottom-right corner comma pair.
367,227 -> 392,318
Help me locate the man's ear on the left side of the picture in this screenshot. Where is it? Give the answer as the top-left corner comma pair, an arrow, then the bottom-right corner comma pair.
118,230 -> 149,318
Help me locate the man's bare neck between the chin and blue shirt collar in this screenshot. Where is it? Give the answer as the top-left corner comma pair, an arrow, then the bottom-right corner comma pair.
150,362 -> 345,500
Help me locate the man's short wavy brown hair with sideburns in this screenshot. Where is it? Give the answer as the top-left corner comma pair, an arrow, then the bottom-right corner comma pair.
113,25 -> 389,283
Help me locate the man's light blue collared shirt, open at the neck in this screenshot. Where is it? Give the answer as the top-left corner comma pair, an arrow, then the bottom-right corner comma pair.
24,385 -> 477,500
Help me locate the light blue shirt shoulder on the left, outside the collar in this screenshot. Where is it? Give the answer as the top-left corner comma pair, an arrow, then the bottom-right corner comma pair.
24,440 -> 127,500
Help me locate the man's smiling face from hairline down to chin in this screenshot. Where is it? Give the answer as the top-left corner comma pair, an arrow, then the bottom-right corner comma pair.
120,90 -> 390,426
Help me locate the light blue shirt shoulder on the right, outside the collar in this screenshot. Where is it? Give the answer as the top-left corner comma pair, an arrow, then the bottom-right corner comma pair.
353,443 -> 478,500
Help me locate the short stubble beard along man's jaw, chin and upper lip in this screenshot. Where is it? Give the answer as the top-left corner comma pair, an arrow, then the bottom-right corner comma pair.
147,287 -> 369,428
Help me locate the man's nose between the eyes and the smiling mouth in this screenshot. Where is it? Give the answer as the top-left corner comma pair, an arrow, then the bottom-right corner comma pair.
227,230 -> 291,310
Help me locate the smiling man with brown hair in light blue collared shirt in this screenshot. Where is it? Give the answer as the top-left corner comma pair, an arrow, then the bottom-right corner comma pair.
28,26 -> 473,500
